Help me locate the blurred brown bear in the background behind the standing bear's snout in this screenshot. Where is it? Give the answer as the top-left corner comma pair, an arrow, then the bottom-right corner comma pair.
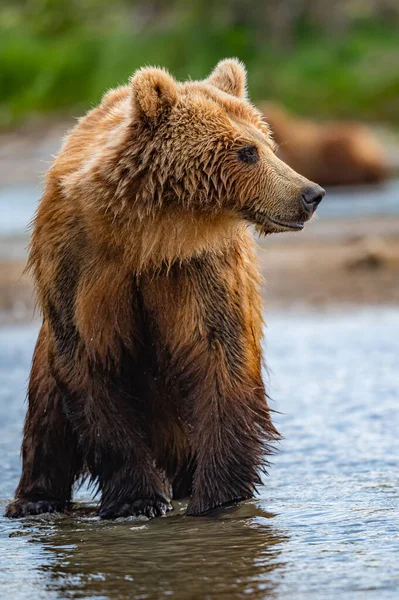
261,102 -> 389,186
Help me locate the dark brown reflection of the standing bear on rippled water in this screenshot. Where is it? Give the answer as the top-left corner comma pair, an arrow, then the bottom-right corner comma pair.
34,501 -> 286,600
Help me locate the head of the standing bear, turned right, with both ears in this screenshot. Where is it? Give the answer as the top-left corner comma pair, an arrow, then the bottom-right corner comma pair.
126,59 -> 324,234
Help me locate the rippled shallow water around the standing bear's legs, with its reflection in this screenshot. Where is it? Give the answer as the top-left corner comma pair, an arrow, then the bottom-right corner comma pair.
0,308 -> 399,600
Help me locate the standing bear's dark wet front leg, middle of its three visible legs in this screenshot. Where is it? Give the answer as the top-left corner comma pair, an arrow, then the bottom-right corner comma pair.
58,348 -> 171,519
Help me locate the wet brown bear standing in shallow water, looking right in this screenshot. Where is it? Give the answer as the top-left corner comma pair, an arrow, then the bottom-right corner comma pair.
6,60 -> 324,518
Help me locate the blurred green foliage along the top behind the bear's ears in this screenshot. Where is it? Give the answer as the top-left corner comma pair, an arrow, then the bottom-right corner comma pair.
0,0 -> 399,126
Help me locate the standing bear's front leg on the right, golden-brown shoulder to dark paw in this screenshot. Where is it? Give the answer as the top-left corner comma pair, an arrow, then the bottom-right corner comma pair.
141,244 -> 279,515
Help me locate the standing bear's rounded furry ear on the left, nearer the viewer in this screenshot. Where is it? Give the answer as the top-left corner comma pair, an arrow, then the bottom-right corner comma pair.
131,67 -> 177,120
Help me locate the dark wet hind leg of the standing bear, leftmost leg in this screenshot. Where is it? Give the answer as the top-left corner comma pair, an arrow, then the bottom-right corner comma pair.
5,325 -> 82,518
